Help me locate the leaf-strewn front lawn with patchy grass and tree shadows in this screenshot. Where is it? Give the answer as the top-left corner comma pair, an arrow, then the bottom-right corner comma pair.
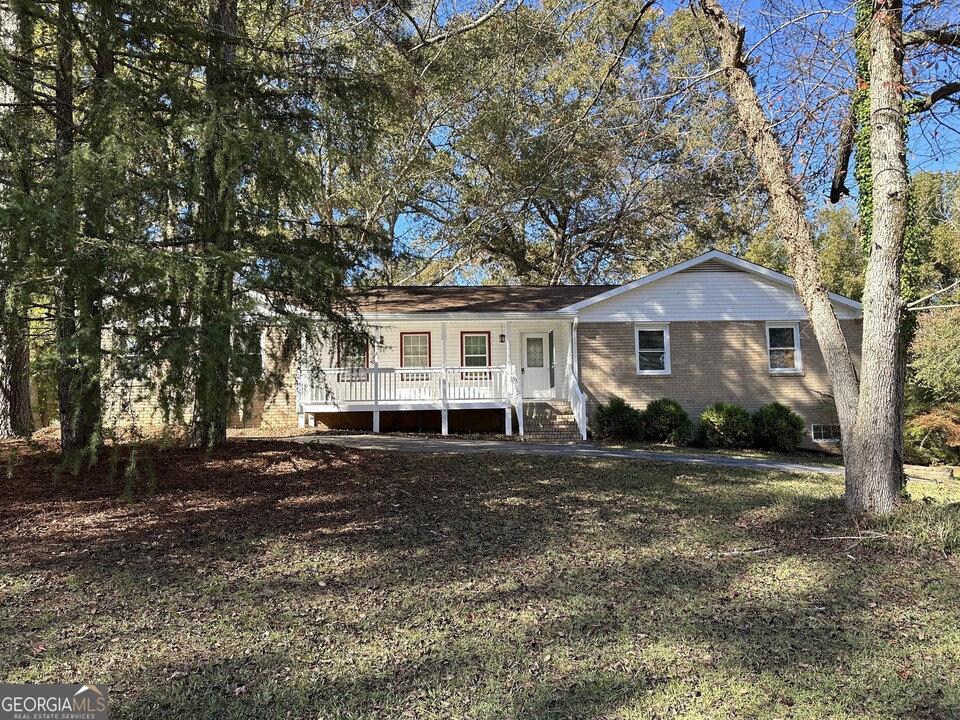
0,440 -> 960,720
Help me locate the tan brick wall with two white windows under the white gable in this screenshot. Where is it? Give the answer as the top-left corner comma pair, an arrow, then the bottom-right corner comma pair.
578,320 -> 860,450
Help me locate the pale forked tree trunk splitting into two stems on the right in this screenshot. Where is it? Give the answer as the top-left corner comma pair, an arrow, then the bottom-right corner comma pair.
699,0 -> 906,513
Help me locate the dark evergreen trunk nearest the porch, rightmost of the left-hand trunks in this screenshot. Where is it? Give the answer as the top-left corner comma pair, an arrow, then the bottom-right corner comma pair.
190,0 -> 237,447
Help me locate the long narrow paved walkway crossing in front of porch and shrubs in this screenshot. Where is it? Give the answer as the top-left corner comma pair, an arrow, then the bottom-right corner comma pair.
291,435 -> 843,475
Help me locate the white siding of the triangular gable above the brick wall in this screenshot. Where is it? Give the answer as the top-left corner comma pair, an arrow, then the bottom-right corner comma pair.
580,268 -> 858,323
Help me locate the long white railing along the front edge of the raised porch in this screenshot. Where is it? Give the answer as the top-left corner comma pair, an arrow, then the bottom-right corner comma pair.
301,367 -> 522,408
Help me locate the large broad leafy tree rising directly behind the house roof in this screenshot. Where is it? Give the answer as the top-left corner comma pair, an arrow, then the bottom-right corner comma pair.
356,1 -> 762,284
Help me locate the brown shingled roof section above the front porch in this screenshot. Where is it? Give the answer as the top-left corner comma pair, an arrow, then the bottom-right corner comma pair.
360,285 -> 618,314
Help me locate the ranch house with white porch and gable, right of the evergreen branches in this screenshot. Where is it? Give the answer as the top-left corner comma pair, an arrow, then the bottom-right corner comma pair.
291,251 -> 861,448
